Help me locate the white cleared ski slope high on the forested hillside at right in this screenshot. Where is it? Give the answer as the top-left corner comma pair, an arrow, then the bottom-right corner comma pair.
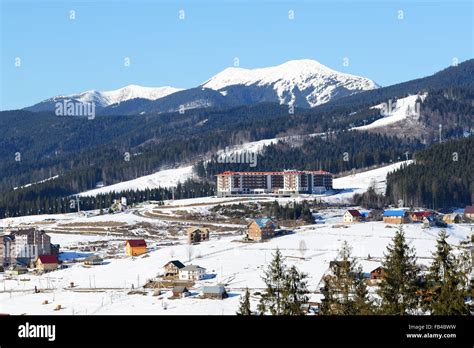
354,93 -> 428,130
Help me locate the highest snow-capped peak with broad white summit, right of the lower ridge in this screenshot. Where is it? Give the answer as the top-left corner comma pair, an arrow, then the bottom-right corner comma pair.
202,59 -> 379,107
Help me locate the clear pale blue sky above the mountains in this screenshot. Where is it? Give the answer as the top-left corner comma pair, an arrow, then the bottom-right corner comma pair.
0,0 -> 474,110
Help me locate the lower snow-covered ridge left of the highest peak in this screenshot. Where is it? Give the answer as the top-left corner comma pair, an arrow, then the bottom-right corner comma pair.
27,85 -> 181,111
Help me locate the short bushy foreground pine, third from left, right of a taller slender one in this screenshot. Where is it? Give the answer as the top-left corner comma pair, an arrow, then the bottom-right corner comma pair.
282,266 -> 309,315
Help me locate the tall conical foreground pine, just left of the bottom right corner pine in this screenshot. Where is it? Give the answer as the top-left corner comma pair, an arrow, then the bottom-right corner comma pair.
379,226 -> 419,315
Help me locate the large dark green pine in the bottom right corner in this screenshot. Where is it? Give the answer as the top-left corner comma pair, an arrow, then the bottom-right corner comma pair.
426,230 -> 469,315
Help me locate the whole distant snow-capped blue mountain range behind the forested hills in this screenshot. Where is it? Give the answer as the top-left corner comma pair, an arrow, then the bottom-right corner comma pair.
25,59 -> 379,115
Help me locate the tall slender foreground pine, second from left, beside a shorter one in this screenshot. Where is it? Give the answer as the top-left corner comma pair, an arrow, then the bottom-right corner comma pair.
258,249 -> 286,315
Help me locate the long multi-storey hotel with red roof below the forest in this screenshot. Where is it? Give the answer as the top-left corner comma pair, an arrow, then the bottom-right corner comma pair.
217,170 -> 332,197
